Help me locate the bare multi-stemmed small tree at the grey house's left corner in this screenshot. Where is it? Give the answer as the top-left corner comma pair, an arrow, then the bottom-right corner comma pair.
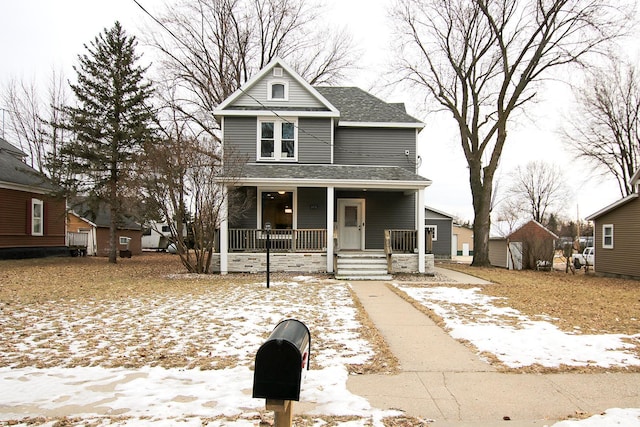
140,85 -> 246,273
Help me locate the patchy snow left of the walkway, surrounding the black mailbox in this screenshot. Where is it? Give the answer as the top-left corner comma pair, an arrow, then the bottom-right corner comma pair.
0,277 -> 398,427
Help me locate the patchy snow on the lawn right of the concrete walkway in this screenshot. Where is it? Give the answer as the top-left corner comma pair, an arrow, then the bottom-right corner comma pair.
395,284 -> 640,368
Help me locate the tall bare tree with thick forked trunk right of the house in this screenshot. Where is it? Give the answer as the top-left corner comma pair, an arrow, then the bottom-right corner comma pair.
395,0 -> 626,266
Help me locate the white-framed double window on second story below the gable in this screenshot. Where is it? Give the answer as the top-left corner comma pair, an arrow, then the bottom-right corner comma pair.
258,118 -> 298,161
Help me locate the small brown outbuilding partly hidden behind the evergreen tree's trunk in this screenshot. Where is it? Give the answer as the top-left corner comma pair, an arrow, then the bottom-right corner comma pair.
67,206 -> 142,256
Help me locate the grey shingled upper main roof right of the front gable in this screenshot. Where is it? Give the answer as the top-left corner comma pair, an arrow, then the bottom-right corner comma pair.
316,86 -> 423,127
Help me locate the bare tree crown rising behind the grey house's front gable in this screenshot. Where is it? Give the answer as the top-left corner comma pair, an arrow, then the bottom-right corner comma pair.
144,0 -> 355,129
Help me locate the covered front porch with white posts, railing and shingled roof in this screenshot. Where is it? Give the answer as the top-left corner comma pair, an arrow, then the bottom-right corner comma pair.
219,164 -> 431,274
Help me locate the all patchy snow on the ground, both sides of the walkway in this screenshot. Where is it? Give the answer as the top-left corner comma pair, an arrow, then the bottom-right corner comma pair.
0,277 -> 640,427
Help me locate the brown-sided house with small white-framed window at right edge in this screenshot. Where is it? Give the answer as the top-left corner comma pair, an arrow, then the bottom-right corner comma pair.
587,169 -> 640,279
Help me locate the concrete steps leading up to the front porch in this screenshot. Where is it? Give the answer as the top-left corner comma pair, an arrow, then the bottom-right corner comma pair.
335,252 -> 392,280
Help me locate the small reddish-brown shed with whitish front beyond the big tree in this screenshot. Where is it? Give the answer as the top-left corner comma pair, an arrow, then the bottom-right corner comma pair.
489,220 -> 558,270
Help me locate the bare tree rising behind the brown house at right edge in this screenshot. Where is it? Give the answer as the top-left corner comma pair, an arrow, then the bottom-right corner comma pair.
563,58 -> 640,197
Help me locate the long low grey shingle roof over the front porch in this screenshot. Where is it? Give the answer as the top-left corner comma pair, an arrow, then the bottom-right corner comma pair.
228,163 -> 431,187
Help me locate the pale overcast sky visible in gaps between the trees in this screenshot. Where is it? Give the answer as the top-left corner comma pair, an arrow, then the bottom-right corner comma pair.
0,0 -> 632,224
